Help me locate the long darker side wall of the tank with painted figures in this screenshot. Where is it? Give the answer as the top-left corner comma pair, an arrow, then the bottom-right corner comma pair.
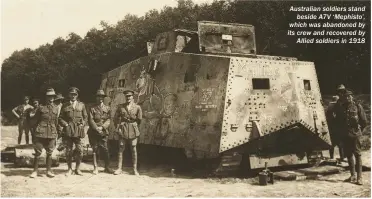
101,53 -> 229,158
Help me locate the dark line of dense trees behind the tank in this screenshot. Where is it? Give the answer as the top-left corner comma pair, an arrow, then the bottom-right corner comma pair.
1,0 -> 370,110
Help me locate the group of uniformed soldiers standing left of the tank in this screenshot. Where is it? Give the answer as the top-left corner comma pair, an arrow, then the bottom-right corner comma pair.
13,87 -> 142,178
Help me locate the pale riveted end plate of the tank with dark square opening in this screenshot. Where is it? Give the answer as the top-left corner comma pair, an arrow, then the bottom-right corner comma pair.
220,57 -> 330,152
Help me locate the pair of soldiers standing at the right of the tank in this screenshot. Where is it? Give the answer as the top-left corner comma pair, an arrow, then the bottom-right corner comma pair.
326,84 -> 367,185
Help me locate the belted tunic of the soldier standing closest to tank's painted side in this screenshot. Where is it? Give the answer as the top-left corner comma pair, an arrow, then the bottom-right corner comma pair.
114,103 -> 142,139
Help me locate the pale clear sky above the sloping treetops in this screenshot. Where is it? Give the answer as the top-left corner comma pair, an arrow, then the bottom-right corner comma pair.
0,0 -> 212,63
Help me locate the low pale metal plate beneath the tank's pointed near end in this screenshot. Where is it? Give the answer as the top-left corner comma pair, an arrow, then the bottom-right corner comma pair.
249,154 -> 308,169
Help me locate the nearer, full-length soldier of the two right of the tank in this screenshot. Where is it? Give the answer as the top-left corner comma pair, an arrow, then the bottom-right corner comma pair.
335,91 -> 367,185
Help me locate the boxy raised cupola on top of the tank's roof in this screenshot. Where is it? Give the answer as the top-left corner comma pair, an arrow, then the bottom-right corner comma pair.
198,21 -> 256,54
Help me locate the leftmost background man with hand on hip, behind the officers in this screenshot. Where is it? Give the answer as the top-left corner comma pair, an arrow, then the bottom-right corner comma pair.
12,96 -> 32,144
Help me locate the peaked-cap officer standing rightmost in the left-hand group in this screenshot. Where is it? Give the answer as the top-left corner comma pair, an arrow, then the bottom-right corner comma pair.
114,90 -> 142,176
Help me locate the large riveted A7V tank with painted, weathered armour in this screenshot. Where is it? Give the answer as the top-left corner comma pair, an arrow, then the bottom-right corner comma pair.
101,21 -> 331,169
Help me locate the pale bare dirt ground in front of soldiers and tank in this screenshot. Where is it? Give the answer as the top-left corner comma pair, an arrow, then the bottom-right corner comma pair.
1,127 -> 371,198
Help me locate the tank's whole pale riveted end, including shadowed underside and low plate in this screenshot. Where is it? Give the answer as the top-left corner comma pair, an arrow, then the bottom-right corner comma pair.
220,56 -> 330,168
